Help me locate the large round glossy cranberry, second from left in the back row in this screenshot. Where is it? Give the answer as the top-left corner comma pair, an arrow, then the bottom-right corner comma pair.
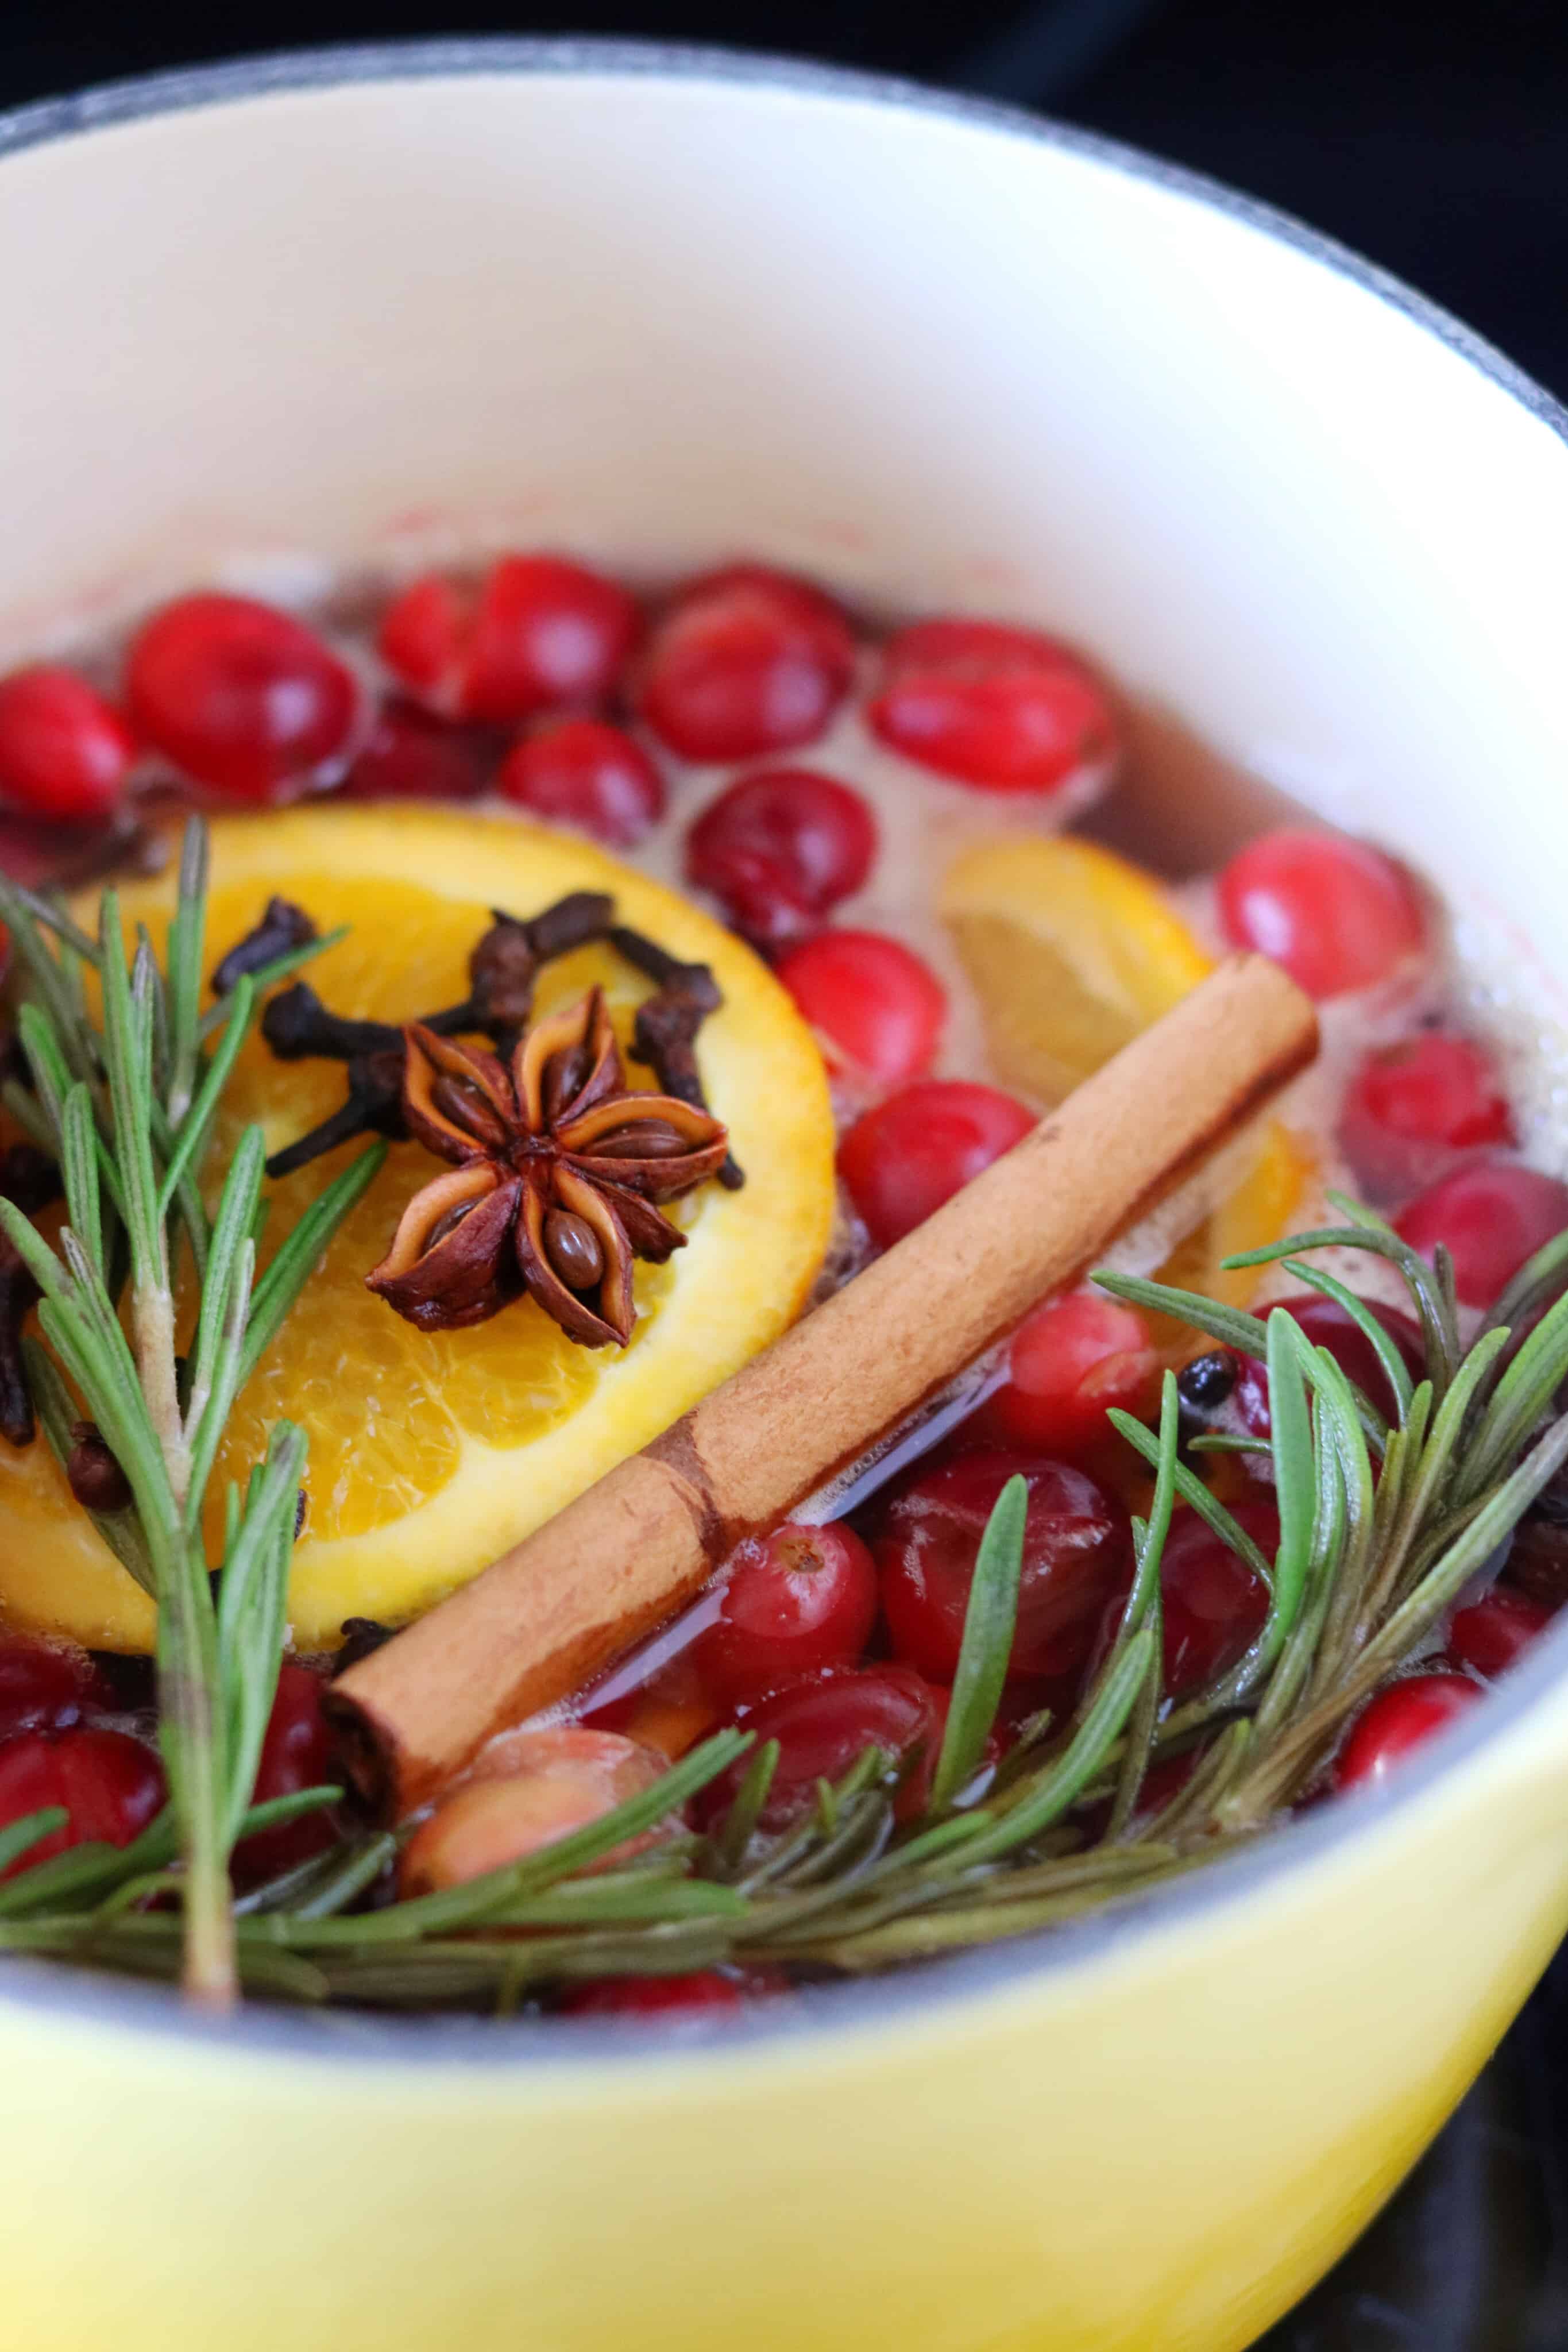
127,595 -> 360,802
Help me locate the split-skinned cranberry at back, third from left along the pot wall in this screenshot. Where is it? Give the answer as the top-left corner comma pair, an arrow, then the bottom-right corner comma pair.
379,555 -> 642,724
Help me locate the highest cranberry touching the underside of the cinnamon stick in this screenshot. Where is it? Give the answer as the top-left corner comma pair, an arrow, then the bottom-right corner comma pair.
983,1291 -> 1159,1456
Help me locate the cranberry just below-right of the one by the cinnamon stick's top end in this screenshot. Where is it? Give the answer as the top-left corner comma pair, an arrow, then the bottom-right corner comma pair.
1340,1030 -> 1514,1200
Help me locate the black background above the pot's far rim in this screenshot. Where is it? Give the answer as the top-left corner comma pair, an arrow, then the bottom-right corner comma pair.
0,0 -> 1568,393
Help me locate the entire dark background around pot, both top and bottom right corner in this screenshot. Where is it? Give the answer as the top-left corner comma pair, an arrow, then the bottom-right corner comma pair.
0,0 -> 1568,2352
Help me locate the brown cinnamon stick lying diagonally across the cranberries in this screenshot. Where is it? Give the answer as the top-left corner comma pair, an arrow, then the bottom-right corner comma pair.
331,955 -> 1316,1816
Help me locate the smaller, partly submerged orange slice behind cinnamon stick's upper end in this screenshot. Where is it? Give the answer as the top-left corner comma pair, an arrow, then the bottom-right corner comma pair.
940,835 -> 1310,1355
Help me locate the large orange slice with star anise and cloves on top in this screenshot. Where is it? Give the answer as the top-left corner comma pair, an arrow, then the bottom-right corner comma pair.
0,807 -> 835,1649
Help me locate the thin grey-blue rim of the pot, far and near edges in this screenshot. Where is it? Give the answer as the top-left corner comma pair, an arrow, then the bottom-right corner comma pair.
0,35 -> 1568,2079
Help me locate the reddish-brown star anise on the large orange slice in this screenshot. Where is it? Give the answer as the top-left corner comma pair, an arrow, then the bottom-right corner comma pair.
367,988 -> 729,1348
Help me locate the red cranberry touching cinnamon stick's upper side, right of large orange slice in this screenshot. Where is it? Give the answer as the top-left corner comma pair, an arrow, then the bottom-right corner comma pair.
839,1077 -> 1034,1249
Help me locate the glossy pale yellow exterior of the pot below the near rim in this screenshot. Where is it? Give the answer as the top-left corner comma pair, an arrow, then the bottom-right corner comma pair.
0,1644 -> 1568,2352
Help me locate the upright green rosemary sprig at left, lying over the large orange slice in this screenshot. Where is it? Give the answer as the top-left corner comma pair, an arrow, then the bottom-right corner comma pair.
0,823 -> 381,2006
